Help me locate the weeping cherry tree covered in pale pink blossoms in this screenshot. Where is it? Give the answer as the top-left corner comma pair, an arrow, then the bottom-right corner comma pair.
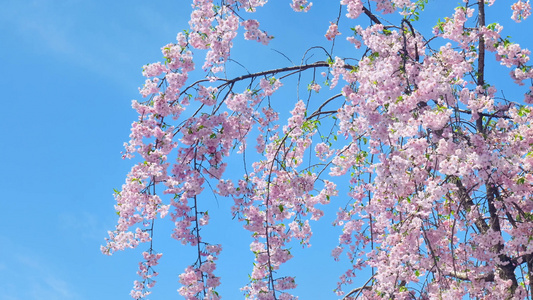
102,0 -> 533,299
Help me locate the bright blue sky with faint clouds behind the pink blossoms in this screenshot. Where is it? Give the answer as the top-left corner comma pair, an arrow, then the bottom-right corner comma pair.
0,0 -> 533,300
